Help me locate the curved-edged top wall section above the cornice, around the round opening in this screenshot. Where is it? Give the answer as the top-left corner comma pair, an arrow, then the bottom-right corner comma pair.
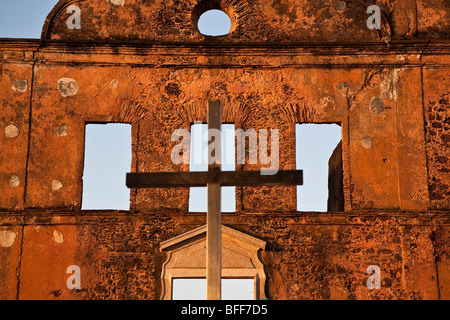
42,0 -> 400,44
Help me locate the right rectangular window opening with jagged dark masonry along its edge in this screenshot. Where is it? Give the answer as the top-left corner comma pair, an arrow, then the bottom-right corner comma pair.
295,123 -> 344,212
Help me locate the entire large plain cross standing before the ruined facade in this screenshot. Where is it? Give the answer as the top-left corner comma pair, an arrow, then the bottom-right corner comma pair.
126,100 -> 303,300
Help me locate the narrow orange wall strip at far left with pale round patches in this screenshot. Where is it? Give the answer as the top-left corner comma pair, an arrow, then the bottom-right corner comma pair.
0,45 -> 33,209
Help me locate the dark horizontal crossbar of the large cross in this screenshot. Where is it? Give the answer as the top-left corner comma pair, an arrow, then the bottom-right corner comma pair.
127,170 -> 303,188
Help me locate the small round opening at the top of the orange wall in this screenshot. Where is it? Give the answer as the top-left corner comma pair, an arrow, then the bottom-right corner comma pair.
197,9 -> 231,37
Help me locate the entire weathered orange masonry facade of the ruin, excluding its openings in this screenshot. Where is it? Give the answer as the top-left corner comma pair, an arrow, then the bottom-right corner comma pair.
0,0 -> 450,299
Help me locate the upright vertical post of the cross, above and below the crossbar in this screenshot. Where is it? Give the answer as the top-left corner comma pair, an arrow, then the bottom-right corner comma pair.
206,100 -> 222,300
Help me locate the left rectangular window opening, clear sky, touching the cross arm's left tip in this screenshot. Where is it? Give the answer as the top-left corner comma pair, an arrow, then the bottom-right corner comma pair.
81,123 -> 131,210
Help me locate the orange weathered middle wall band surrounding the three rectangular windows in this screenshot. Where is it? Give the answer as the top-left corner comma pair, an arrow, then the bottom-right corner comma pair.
0,58 -> 446,211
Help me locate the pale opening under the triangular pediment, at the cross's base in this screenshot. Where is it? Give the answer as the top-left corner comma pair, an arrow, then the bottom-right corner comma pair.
172,278 -> 255,300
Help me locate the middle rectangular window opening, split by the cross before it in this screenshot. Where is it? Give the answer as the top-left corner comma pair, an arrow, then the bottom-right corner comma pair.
189,123 -> 236,212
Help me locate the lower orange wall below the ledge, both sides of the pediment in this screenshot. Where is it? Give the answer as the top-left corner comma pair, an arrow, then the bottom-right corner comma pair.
0,212 -> 450,299
